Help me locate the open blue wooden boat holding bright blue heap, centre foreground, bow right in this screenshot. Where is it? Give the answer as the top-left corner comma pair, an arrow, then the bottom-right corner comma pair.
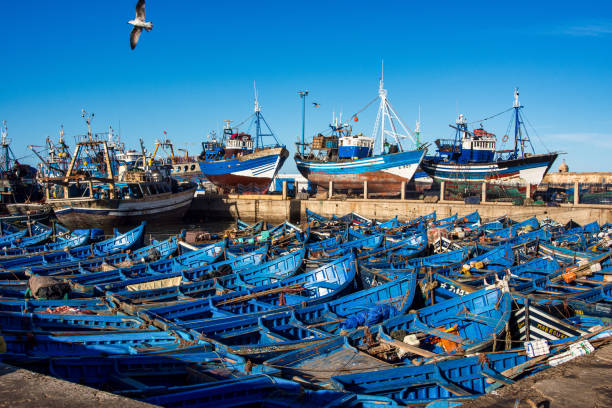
183,274 -> 416,360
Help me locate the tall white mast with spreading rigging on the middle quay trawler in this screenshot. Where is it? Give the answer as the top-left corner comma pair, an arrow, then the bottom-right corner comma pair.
372,61 -> 418,153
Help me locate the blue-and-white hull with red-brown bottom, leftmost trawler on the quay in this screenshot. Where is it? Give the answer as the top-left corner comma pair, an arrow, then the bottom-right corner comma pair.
199,147 -> 289,193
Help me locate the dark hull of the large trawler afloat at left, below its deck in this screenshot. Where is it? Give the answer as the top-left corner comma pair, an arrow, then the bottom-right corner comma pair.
49,187 -> 195,228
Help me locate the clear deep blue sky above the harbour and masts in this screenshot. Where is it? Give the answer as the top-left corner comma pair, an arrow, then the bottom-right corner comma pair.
0,0 -> 612,172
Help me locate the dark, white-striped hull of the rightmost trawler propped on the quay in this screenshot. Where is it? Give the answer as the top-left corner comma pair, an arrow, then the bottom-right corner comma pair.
421,153 -> 558,186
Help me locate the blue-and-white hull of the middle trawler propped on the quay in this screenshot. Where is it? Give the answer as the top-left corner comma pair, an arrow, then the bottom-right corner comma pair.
295,150 -> 425,194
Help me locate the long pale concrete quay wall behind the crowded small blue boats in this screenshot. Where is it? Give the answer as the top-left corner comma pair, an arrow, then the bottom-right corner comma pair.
190,195 -> 612,224
